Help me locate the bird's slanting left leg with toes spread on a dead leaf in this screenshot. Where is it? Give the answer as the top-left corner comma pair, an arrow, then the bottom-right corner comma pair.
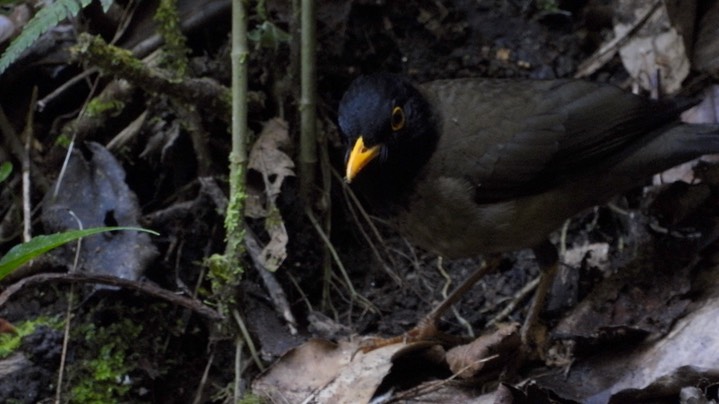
361,254 -> 501,352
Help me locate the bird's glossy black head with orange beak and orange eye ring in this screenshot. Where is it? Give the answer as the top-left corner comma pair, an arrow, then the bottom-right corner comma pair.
338,74 -> 438,193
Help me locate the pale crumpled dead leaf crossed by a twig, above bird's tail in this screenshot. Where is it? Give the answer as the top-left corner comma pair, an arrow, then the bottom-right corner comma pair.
614,0 -> 689,94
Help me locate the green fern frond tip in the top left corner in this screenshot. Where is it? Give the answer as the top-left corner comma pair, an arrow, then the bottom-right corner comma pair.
0,0 -> 92,74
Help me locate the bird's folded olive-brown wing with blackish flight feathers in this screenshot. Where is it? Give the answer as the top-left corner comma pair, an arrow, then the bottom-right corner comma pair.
423,79 -> 683,203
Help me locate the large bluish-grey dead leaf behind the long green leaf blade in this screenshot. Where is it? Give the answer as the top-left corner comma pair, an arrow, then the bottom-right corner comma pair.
41,142 -> 157,280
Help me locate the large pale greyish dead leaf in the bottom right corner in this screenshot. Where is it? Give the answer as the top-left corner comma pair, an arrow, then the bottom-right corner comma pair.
538,268 -> 719,403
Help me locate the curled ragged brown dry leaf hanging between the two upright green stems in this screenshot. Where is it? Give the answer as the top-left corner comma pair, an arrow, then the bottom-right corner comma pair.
245,118 -> 295,271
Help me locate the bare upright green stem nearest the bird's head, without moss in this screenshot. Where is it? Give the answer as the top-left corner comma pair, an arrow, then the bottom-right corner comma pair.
299,0 -> 317,203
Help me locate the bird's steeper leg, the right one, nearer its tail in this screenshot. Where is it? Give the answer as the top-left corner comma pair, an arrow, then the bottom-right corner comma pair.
520,240 -> 559,357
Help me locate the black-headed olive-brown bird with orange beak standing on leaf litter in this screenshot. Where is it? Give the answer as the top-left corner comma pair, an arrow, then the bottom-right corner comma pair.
337,73 -> 719,356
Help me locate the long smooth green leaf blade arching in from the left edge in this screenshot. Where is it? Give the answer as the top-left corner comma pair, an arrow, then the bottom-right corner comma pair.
0,227 -> 159,279
